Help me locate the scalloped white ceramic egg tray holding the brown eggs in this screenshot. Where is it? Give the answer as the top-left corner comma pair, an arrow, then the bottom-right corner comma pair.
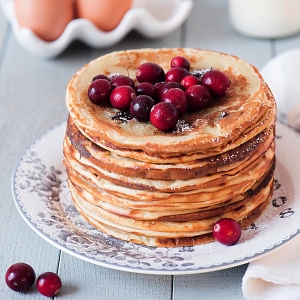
1,0 -> 193,58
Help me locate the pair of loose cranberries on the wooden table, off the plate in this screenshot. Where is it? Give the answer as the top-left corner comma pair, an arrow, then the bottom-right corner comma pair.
5,262 -> 62,297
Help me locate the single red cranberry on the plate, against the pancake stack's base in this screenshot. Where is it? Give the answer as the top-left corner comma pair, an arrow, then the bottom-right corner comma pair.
213,218 -> 242,246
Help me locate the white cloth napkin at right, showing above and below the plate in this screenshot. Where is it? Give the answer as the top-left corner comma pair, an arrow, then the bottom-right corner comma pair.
242,49 -> 300,300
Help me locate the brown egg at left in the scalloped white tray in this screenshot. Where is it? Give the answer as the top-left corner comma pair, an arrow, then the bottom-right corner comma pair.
14,0 -> 74,42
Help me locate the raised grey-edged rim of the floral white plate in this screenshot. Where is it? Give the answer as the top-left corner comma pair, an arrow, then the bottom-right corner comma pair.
12,121 -> 300,274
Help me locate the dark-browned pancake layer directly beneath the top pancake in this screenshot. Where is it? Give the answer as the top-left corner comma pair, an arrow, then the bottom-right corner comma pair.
65,117 -> 275,180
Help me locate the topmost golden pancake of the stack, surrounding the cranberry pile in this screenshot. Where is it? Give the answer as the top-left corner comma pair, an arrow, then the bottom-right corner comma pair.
66,49 -> 276,163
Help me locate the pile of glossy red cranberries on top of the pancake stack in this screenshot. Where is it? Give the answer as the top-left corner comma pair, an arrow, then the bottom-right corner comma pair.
88,56 -> 231,131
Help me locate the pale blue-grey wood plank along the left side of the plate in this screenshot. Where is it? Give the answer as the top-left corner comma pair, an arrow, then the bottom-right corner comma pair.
0,29 -> 91,299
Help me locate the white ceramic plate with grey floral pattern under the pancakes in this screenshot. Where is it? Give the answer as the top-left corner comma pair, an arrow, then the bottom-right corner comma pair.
12,122 -> 300,274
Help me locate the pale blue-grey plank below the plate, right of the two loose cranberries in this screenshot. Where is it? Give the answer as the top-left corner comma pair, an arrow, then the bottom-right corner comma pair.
59,254 -> 172,300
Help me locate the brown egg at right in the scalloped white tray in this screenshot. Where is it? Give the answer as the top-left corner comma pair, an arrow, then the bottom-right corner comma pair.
75,0 -> 132,31
